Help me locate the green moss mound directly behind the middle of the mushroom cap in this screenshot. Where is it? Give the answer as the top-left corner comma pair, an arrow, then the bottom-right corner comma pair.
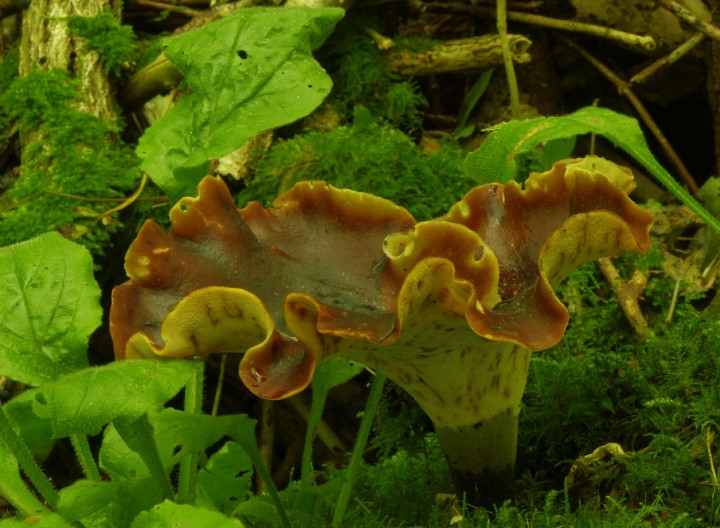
238,111 -> 473,220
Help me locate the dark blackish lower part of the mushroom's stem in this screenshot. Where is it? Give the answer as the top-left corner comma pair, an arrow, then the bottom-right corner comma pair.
436,409 -> 518,508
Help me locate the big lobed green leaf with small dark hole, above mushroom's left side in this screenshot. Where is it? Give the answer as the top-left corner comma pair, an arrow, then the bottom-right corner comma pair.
137,8 -> 344,199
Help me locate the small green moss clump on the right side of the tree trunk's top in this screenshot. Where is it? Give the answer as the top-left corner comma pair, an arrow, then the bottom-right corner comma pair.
66,11 -> 135,76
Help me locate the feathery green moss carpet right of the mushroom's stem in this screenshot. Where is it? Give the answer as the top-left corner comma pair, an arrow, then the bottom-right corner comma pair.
518,255 -> 720,526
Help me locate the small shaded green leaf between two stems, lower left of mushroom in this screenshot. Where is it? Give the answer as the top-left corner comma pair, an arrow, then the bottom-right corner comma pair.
198,442 -> 252,515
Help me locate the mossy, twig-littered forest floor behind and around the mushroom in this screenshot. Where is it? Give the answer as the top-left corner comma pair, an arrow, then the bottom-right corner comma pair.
0,0 -> 720,528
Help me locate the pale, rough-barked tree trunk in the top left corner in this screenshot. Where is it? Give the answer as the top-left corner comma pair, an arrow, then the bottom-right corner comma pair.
20,0 -> 121,120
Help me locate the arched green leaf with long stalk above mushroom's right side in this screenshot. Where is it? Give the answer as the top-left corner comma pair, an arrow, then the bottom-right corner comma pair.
465,107 -> 720,232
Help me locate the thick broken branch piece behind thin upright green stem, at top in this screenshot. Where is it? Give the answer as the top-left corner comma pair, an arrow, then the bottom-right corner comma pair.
387,35 -> 532,77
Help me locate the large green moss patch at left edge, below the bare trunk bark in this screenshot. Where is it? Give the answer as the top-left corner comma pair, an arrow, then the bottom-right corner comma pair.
0,70 -> 139,252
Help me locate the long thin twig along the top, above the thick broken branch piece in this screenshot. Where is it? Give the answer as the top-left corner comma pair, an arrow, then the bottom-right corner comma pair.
425,2 -> 655,51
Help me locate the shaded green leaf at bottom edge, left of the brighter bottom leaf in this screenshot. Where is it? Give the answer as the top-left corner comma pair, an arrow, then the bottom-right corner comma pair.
58,479 -> 162,528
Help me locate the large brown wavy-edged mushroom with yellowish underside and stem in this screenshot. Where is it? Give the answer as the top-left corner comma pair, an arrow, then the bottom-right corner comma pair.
110,156 -> 652,505
